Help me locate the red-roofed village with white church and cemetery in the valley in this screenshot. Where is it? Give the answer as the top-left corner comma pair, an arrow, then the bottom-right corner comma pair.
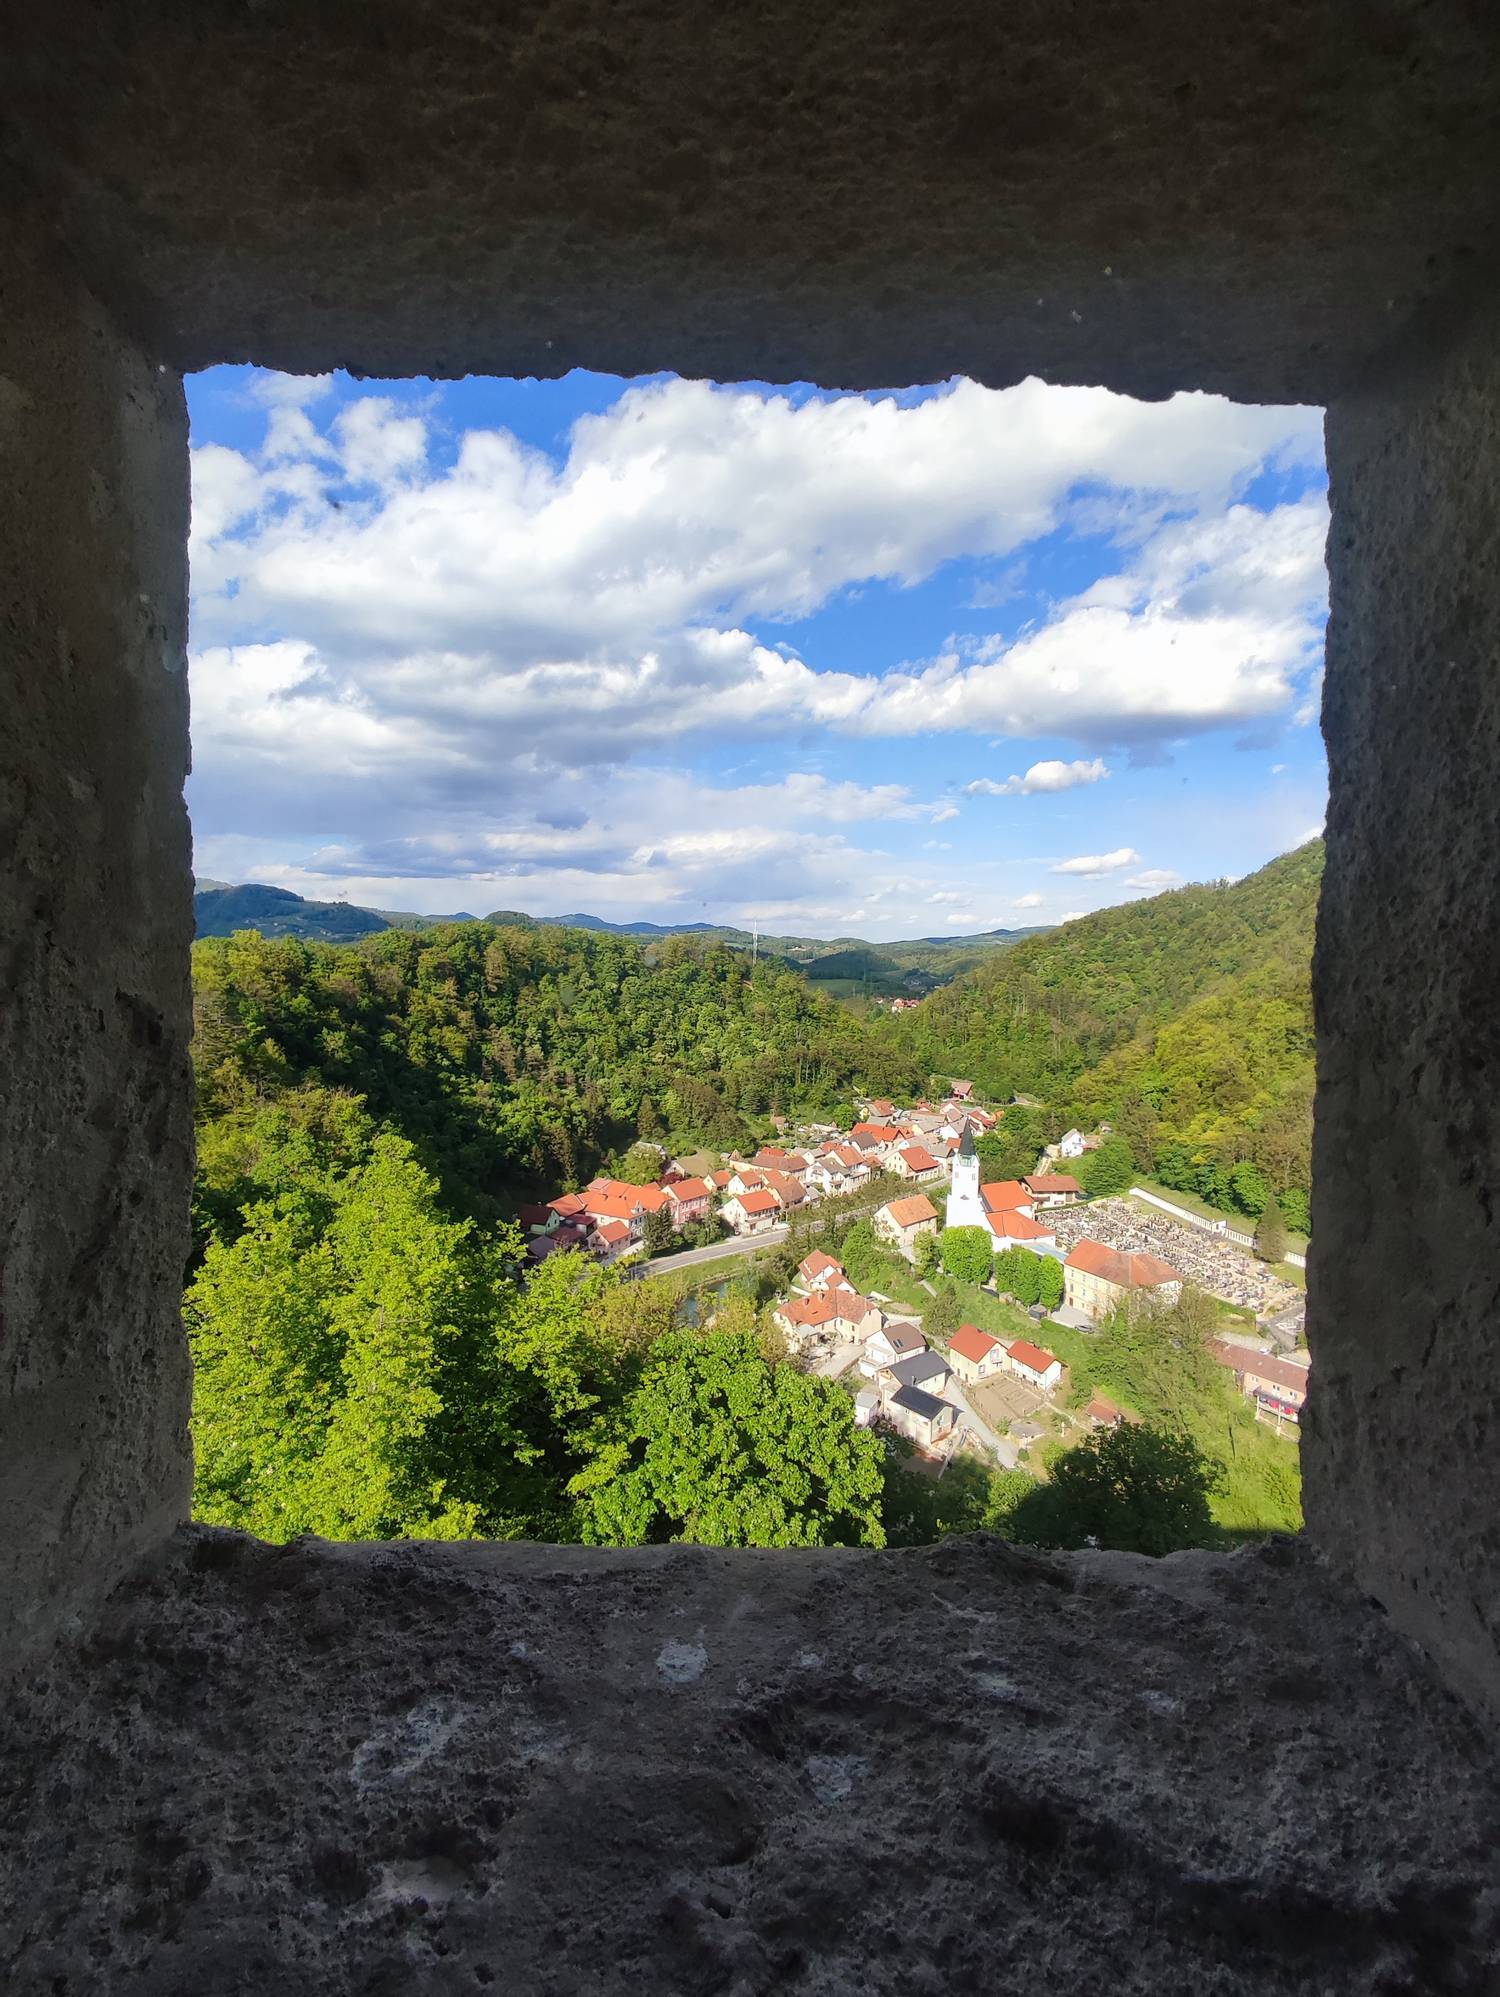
519,1080 -> 1308,1474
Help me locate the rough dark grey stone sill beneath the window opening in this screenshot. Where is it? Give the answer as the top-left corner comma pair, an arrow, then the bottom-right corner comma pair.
0,1528 -> 1500,1997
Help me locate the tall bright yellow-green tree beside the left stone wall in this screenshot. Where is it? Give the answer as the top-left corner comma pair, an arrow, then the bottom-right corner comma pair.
184,1134 -> 507,1540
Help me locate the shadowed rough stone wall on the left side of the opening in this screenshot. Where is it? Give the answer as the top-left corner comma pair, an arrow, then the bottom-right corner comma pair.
0,210 -> 192,1669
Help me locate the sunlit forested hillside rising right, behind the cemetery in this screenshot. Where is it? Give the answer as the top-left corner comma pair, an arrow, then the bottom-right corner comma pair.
889,839 -> 1322,1196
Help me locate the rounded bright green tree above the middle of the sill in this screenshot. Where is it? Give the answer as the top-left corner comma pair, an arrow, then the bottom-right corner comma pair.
571,1330 -> 885,1546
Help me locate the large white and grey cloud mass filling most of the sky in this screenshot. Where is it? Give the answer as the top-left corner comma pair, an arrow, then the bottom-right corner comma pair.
190,375 -> 1326,933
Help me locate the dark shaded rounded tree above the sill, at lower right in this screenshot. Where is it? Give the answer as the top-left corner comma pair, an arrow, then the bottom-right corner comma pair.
1009,1422 -> 1222,1554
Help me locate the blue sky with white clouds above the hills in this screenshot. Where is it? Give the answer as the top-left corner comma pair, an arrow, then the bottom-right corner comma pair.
188,367 -> 1326,937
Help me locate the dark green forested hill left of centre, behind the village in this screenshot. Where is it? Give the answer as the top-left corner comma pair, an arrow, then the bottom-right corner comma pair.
194,923 -> 921,1218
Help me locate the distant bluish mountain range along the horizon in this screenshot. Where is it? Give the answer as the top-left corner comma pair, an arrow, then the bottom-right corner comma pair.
194,881 -> 1037,999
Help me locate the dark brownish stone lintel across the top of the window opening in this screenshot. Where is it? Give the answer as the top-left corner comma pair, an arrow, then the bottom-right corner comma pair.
0,0 -> 1500,401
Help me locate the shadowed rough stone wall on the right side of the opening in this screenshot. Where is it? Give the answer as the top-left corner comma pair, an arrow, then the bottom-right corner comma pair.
1302,303 -> 1500,1715
